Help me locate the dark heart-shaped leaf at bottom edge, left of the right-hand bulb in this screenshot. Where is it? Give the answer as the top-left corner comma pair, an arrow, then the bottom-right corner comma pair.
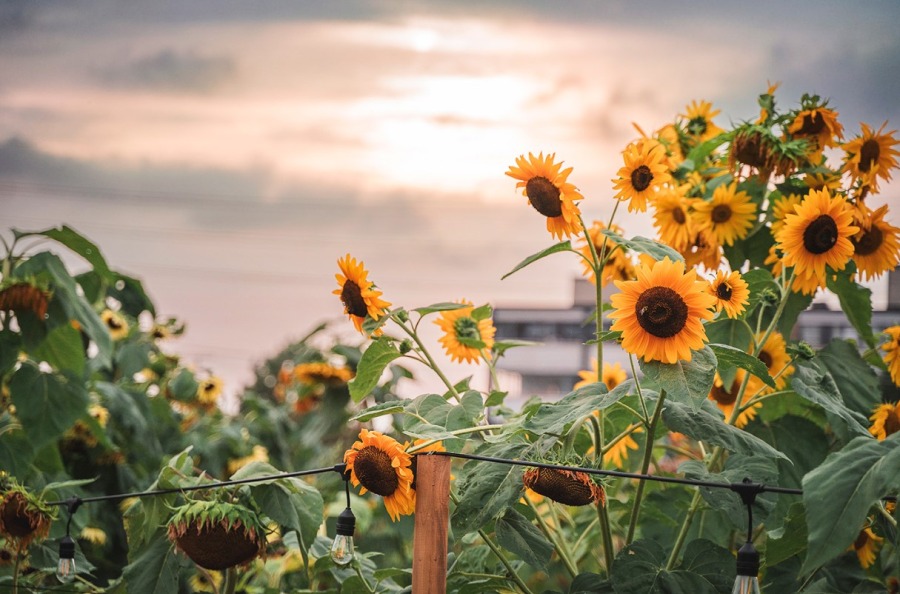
610,539 -> 735,594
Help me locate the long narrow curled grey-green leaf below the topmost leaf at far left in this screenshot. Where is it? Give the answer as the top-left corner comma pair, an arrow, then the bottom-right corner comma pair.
17,252 -> 112,366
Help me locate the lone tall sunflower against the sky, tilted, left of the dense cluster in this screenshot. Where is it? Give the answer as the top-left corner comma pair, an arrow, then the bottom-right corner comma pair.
506,153 -> 584,240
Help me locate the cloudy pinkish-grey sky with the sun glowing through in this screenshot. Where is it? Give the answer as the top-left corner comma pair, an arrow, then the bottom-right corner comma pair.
0,0 -> 900,400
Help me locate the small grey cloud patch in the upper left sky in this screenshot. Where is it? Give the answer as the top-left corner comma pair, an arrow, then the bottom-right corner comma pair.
97,49 -> 237,93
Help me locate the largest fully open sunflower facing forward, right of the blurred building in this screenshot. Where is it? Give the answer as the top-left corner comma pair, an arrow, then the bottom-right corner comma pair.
609,257 -> 715,363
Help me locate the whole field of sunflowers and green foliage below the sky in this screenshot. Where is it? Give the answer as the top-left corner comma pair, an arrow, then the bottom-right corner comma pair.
0,86 -> 900,594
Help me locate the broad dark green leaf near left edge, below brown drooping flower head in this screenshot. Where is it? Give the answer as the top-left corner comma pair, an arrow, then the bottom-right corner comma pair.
9,363 -> 90,450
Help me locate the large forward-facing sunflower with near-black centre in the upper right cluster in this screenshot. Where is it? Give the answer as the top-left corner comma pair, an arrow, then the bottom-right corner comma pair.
775,190 -> 859,283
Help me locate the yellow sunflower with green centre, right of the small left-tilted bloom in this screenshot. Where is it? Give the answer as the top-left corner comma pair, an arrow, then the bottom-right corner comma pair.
434,300 -> 497,363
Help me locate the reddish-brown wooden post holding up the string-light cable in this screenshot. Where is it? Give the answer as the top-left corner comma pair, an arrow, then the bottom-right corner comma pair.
413,454 -> 450,594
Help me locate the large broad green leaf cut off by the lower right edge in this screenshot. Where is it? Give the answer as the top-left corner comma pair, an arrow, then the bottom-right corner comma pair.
802,433 -> 900,575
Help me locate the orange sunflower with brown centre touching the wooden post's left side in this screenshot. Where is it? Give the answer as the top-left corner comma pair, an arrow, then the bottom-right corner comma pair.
344,429 -> 415,522
